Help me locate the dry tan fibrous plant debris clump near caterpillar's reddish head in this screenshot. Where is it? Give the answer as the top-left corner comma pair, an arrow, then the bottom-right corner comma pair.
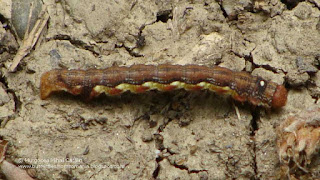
277,107 -> 320,179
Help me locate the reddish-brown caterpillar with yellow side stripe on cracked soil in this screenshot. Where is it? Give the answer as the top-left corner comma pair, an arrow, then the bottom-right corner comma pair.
40,64 -> 287,108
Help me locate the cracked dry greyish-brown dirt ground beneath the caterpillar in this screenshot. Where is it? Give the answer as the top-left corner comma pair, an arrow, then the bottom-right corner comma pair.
0,0 -> 320,179
